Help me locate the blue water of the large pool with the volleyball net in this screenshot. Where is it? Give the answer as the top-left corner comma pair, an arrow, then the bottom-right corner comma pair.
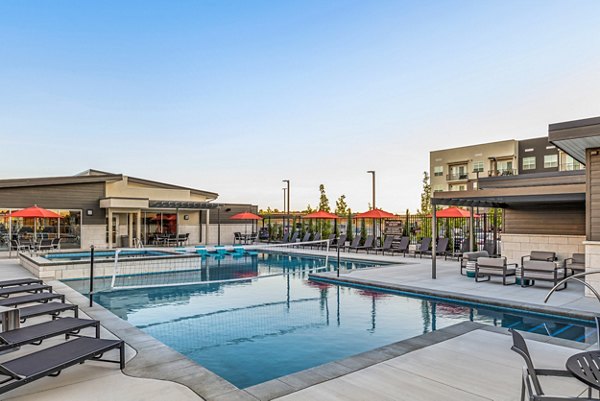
66,253 -> 595,388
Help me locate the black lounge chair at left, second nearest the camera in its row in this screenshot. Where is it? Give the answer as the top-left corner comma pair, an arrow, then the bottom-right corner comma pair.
0,317 -> 100,352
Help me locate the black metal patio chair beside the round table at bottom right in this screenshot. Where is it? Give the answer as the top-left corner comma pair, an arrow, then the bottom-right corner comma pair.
508,329 -> 597,401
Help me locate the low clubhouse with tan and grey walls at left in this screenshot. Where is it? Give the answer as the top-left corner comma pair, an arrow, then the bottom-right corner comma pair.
0,170 -> 258,248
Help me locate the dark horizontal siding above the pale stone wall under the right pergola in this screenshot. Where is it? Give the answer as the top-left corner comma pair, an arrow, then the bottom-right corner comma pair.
504,203 -> 585,235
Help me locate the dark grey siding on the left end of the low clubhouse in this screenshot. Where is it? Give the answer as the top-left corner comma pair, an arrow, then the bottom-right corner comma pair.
0,182 -> 106,224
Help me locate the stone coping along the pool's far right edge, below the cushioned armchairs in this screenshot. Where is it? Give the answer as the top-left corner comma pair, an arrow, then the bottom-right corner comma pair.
308,273 -> 596,321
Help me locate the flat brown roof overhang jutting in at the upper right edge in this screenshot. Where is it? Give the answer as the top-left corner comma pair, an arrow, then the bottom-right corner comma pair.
548,117 -> 600,164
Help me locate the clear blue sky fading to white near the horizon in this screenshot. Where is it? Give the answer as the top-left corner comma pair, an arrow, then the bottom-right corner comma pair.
0,0 -> 600,212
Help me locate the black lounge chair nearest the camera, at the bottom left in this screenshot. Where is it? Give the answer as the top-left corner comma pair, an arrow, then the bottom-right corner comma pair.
0,337 -> 125,394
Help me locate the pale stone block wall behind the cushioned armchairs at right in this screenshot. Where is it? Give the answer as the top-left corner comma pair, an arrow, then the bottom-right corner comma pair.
501,233 -> 584,266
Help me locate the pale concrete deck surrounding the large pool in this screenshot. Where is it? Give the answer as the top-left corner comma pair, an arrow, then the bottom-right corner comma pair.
0,251 -> 600,401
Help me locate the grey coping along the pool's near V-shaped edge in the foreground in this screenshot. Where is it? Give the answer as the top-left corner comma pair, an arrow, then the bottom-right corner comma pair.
51,281 -> 588,401
